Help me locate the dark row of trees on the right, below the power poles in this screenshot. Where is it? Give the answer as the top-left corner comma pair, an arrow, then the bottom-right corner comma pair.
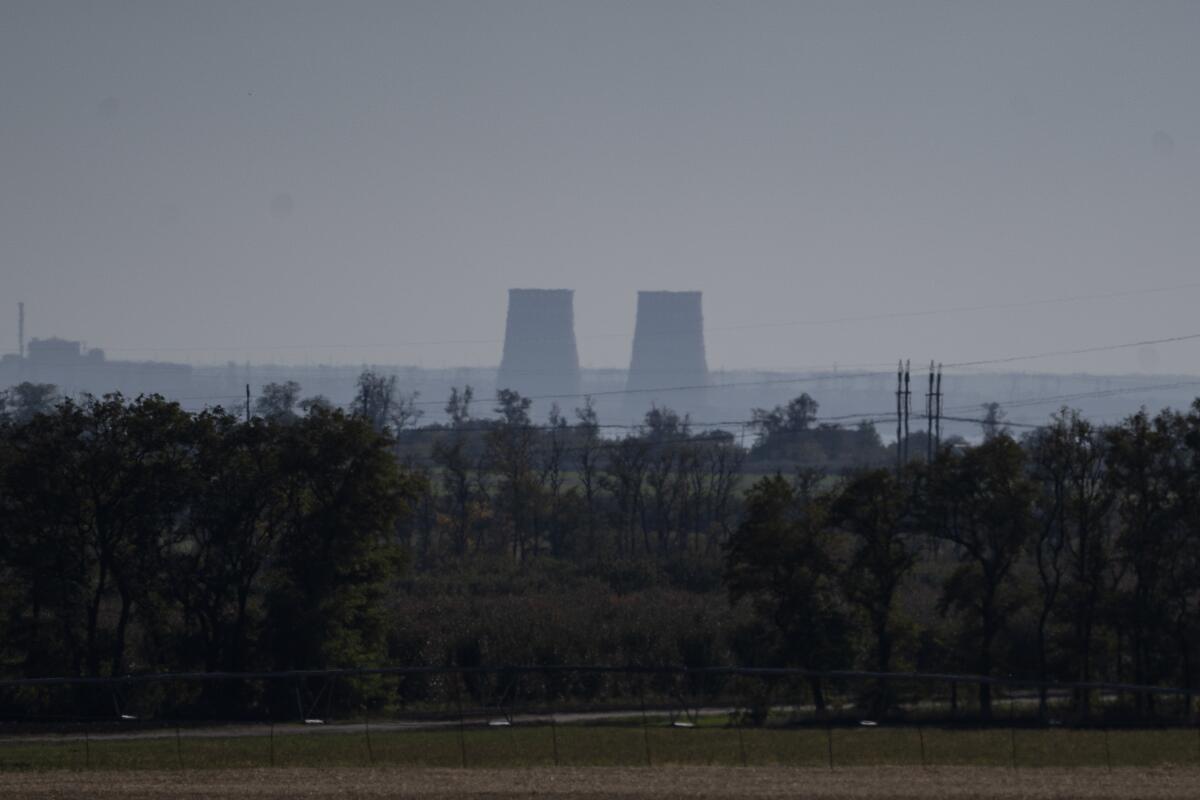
726,401 -> 1200,715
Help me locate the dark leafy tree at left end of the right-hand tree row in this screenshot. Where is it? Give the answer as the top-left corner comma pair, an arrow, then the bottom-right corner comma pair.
725,475 -> 848,710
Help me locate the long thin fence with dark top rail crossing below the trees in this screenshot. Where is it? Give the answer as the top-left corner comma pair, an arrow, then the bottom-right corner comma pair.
0,666 -> 1200,769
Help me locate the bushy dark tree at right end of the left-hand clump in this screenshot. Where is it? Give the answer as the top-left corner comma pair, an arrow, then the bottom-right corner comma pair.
264,411 -> 421,669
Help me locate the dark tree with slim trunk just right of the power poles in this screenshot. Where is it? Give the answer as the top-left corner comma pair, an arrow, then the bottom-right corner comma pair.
926,434 -> 1034,718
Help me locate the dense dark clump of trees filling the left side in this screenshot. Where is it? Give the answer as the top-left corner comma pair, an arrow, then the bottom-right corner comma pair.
0,395 -> 419,675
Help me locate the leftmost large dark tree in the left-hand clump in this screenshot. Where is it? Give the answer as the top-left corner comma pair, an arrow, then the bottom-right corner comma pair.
5,395 -> 191,675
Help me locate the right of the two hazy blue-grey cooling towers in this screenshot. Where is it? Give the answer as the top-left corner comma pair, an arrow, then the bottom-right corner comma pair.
626,291 -> 708,398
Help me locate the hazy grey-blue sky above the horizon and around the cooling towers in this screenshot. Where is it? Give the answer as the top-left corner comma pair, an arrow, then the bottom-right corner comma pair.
0,0 -> 1200,372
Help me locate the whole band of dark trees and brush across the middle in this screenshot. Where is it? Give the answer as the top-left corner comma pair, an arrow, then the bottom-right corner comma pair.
0,372 -> 1200,729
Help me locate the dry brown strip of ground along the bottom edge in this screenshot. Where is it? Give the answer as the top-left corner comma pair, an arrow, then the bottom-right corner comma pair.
0,766 -> 1200,800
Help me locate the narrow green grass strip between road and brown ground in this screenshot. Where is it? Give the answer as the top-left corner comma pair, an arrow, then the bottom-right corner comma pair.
0,724 -> 1200,772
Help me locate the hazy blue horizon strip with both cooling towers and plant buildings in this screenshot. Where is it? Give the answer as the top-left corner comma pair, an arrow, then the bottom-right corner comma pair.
9,298 -> 1195,437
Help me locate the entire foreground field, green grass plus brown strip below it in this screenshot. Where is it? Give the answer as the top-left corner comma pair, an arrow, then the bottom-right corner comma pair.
7,721 -> 1200,800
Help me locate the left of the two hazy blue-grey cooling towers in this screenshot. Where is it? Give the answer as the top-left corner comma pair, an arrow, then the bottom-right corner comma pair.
497,289 -> 580,397
